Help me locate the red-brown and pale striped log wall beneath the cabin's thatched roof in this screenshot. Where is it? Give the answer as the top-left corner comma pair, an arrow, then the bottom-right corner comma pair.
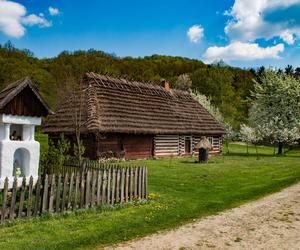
50,134 -> 221,160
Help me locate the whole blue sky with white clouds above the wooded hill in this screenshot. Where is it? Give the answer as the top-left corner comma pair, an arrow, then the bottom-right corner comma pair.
0,0 -> 300,67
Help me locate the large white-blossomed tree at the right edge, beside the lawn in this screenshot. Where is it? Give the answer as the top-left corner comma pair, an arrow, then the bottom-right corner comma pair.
250,70 -> 300,154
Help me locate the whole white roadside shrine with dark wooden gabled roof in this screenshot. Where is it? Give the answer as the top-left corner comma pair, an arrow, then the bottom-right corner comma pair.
0,77 -> 51,187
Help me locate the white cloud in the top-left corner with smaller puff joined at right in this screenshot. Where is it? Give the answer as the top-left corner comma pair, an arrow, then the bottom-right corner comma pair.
0,0 -> 51,38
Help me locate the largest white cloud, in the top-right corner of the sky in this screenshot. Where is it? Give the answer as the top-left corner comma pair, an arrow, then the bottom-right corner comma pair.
225,0 -> 300,45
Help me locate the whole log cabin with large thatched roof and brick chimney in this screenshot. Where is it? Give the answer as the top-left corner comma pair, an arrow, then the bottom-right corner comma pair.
43,73 -> 225,159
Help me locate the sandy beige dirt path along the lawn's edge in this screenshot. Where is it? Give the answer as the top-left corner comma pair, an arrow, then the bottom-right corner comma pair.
107,183 -> 300,250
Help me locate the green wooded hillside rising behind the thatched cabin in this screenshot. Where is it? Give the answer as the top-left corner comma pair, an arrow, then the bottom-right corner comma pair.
0,42 -> 298,128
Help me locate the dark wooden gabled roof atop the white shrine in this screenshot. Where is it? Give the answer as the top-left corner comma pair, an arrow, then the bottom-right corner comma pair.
0,77 -> 53,116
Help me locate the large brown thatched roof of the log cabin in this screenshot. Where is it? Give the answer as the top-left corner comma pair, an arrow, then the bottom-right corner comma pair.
44,73 -> 225,134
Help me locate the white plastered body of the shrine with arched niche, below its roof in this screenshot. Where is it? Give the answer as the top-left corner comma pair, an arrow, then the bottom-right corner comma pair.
0,114 -> 41,188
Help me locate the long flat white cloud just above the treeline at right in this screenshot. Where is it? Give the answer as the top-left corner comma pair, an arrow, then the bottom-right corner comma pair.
204,41 -> 284,62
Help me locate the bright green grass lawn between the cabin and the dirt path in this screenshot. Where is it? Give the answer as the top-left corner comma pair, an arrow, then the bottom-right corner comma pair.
0,144 -> 300,249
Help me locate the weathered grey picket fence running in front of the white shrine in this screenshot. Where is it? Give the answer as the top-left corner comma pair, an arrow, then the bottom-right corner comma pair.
0,167 -> 148,223
